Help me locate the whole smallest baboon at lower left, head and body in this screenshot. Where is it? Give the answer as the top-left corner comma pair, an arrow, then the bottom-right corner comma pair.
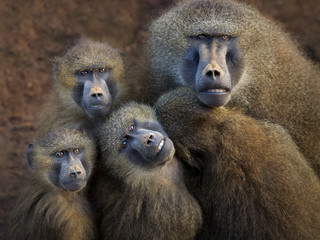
8,128 -> 97,240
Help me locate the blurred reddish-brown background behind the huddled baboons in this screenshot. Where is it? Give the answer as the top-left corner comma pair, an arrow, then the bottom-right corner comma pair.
0,0 -> 320,239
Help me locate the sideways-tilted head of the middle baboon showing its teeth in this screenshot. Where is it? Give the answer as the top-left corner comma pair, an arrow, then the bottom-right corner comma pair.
97,103 -> 180,180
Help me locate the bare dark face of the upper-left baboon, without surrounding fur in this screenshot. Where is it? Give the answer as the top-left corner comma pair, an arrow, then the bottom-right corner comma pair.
72,67 -> 116,118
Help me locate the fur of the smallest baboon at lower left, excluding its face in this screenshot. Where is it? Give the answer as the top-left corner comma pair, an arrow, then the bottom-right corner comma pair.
8,129 -> 97,240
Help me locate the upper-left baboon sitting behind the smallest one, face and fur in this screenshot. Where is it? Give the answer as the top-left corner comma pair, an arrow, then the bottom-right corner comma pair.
39,39 -> 128,136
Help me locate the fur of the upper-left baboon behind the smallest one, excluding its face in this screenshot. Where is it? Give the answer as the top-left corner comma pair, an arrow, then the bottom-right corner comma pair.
38,39 -> 127,136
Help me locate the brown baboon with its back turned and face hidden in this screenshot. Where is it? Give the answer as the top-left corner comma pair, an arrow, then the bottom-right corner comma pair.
156,88 -> 320,240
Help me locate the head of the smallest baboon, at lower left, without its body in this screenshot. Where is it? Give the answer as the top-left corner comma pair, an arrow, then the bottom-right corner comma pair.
27,129 -> 93,192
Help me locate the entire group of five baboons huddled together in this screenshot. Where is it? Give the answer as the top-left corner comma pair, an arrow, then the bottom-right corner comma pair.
8,0 -> 320,240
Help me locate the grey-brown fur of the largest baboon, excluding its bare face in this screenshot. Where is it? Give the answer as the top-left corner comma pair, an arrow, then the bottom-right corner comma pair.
142,0 -> 320,175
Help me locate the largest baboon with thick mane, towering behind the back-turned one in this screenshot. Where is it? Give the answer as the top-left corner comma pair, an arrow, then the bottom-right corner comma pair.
142,0 -> 320,174
